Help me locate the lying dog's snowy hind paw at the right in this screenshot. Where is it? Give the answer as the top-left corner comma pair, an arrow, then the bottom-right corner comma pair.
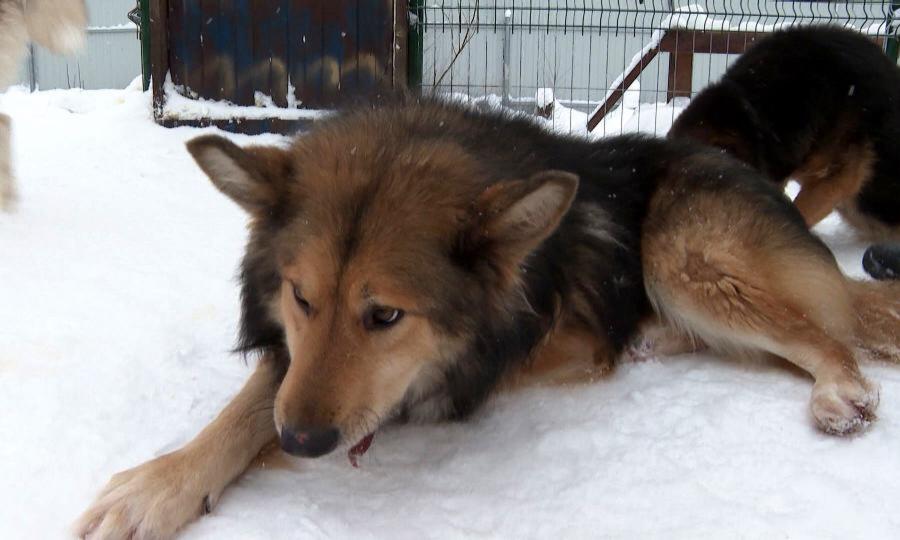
812,377 -> 879,435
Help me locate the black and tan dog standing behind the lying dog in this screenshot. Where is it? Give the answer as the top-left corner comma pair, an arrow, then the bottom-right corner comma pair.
669,26 -> 900,239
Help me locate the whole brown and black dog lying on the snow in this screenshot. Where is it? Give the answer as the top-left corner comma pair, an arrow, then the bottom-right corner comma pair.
76,102 -> 900,538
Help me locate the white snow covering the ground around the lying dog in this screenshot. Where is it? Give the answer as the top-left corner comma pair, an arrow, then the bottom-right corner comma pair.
0,89 -> 900,539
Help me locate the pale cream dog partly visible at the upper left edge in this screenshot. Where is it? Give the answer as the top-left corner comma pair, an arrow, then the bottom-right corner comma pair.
0,0 -> 87,209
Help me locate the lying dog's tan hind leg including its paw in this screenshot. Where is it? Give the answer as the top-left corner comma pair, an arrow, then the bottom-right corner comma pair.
642,168 -> 878,434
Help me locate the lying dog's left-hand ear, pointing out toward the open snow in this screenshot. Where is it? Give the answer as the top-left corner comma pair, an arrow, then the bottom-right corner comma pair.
187,135 -> 292,214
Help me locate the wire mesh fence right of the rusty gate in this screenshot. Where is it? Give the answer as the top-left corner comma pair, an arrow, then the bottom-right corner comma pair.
410,0 -> 900,134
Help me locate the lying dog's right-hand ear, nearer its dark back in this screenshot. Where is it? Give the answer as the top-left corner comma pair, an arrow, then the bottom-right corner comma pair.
466,171 -> 578,274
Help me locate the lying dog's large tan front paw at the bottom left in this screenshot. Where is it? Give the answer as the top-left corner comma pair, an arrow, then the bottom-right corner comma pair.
74,450 -> 219,539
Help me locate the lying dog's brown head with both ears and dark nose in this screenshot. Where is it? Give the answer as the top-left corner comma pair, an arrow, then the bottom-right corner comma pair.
188,116 -> 577,456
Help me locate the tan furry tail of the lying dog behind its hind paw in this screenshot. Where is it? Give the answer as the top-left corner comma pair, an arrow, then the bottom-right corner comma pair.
848,280 -> 900,363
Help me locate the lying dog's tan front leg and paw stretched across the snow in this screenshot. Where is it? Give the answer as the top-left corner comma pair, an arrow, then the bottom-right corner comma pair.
75,356 -> 284,538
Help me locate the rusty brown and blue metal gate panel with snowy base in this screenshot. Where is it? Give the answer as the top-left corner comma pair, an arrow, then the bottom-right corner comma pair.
150,0 -> 407,132
